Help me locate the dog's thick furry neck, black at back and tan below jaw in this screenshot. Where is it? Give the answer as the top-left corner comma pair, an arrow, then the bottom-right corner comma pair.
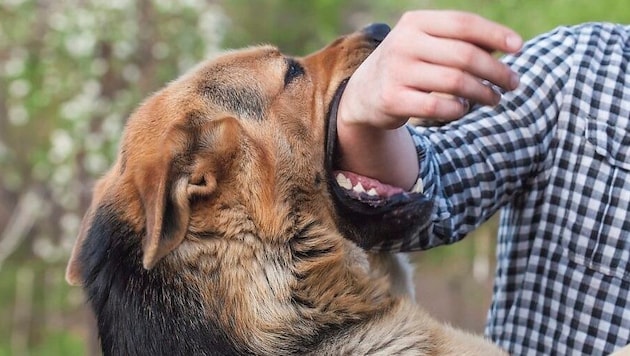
76,196 -> 392,355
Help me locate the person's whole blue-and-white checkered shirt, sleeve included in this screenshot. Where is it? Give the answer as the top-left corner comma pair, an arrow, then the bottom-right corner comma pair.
391,23 -> 630,355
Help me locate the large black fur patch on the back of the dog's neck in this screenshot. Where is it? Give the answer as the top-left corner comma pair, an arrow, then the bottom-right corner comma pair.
80,206 -> 239,356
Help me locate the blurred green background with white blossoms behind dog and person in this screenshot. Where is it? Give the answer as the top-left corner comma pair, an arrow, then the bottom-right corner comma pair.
0,0 -> 630,355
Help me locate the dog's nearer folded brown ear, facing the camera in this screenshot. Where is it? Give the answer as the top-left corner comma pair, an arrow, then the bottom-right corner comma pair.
140,117 -> 239,269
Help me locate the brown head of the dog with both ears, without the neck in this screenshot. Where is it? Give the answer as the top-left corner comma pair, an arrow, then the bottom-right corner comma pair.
67,26 -> 430,284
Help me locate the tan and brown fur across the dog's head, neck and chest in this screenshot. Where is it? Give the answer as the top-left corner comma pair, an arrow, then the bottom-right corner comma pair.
67,27 -> 508,355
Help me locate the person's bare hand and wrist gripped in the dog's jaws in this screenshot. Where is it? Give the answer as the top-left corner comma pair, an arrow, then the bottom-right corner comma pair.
337,11 -> 522,189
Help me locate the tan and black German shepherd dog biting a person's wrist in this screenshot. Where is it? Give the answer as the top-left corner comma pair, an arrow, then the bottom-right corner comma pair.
66,25 -> 502,355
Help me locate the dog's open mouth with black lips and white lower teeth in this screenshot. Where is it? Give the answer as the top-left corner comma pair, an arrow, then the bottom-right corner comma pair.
325,80 -> 433,250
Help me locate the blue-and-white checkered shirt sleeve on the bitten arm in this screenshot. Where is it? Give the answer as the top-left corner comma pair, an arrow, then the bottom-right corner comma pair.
376,27 -> 575,250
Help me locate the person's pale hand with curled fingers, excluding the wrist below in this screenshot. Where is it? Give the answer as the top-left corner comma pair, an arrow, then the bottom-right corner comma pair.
337,11 -> 522,129
